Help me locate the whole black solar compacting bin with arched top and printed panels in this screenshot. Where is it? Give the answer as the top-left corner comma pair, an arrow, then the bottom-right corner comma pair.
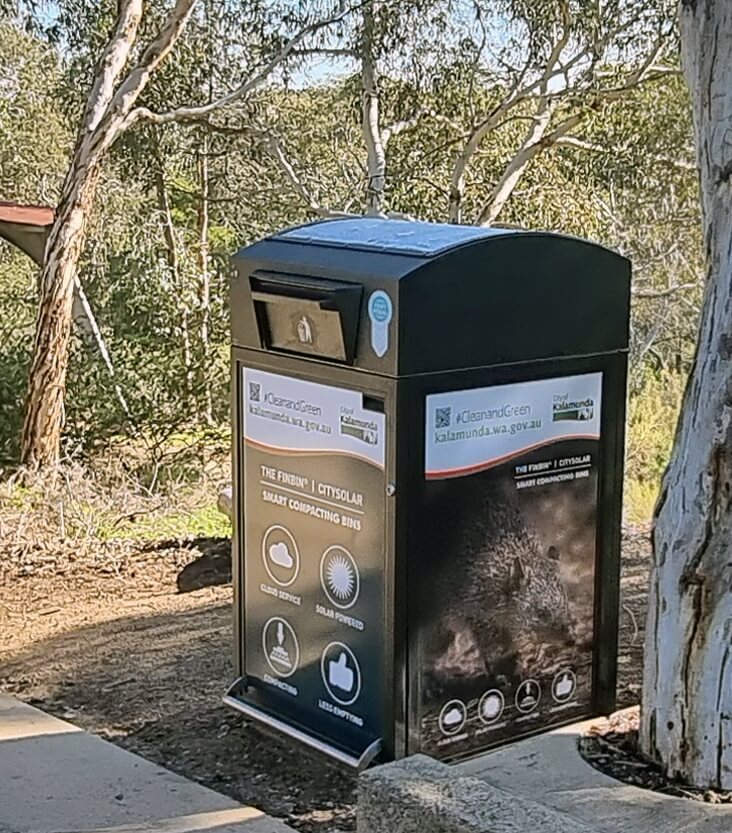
225,219 -> 630,766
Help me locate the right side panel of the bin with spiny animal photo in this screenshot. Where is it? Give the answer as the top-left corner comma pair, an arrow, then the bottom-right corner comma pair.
415,373 -> 603,758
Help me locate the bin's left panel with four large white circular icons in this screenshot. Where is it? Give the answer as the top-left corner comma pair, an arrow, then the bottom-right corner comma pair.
240,368 -> 386,754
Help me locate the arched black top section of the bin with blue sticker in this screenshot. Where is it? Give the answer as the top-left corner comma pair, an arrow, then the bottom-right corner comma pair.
231,217 -> 631,376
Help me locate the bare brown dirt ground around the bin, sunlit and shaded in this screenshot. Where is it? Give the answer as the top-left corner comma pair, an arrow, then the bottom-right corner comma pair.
0,528 -> 649,833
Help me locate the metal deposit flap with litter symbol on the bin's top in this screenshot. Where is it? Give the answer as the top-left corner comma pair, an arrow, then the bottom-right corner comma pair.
250,272 -> 363,364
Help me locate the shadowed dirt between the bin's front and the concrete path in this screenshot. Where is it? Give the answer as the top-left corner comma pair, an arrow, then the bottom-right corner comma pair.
0,603 -> 355,831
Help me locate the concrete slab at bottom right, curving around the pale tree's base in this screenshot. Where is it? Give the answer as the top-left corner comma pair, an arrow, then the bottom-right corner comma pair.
455,720 -> 732,833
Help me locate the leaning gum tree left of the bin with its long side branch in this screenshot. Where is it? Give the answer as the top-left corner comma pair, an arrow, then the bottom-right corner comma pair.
21,0 -> 348,467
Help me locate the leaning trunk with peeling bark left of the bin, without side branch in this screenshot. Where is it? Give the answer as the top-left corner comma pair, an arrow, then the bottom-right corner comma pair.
21,0 -> 196,467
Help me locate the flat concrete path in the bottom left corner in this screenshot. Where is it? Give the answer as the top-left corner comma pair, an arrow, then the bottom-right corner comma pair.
0,695 -> 292,833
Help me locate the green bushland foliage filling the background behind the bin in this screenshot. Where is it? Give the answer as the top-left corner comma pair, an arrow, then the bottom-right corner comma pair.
0,0 -> 702,508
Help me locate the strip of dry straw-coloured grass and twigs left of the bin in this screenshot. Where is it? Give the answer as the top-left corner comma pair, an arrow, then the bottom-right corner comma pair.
0,443 -> 230,582
